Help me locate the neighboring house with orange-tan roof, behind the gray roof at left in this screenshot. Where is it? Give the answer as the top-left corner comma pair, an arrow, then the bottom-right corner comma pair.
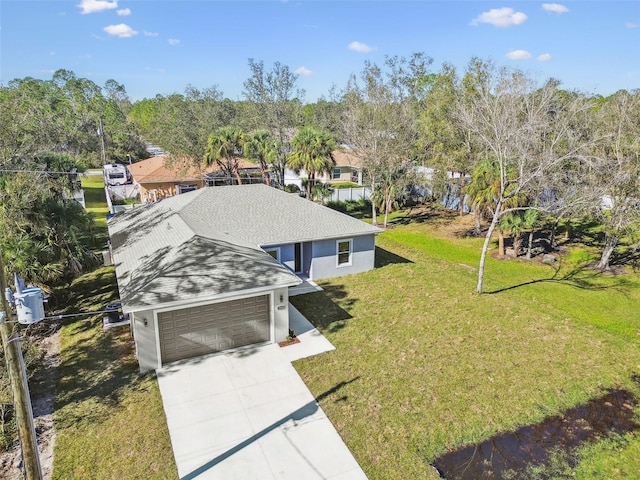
129,155 -> 260,203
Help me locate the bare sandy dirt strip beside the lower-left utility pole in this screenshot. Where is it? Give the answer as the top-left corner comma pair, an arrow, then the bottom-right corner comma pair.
0,325 -> 60,480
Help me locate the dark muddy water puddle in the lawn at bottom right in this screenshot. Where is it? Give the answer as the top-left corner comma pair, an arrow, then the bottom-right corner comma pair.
433,390 -> 640,480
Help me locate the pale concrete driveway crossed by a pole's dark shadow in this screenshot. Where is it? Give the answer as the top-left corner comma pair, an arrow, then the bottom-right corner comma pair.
158,310 -> 367,480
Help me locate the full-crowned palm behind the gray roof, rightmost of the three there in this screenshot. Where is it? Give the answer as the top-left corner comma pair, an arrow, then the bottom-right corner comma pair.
287,127 -> 336,200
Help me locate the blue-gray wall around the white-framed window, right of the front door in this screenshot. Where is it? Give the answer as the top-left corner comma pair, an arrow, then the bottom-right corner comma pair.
309,234 -> 376,280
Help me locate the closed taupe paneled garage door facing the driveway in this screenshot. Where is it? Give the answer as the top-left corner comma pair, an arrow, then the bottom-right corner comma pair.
158,295 -> 271,364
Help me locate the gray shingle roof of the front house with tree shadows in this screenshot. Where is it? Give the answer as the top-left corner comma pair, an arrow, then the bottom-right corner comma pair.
109,185 -> 381,311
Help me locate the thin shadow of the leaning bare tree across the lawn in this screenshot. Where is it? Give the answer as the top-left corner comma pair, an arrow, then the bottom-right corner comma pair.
485,264 -> 636,294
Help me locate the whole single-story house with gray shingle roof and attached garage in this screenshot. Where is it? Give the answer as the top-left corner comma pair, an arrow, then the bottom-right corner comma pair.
108,184 -> 381,372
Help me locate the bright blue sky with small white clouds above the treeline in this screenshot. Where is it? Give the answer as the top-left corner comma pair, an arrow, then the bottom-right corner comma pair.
0,0 -> 640,101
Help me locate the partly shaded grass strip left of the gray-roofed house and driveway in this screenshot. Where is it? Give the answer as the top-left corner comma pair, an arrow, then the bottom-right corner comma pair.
53,176 -> 178,480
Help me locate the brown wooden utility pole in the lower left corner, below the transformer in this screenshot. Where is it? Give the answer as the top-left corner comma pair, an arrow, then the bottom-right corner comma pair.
0,252 -> 42,480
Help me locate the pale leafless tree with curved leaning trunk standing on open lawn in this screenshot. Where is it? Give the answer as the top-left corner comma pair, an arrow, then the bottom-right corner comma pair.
457,59 -> 594,293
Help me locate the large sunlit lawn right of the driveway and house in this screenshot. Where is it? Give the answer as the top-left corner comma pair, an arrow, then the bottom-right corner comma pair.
291,218 -> 640,480
